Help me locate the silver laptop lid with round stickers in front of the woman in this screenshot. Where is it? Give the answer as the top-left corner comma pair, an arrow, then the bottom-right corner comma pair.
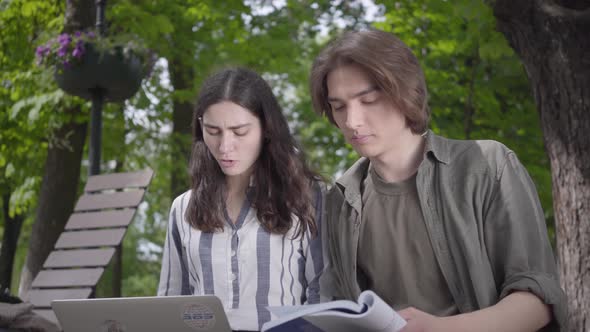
51,295 -> 231,332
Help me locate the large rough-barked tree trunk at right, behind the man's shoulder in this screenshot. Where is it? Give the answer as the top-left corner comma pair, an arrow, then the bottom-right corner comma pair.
492,0 -> 590,332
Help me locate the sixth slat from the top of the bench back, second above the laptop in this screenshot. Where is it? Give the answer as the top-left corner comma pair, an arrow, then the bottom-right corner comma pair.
31,268 -> 104,288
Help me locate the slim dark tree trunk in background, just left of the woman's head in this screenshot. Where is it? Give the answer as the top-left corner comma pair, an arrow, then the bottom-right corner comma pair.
168,59 -> 194,198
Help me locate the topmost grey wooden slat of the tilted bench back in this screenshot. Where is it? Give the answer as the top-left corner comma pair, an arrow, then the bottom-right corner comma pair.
84,169 -> 154,192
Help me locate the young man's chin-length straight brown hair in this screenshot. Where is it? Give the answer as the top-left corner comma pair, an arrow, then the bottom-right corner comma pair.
309,29 -> 430,134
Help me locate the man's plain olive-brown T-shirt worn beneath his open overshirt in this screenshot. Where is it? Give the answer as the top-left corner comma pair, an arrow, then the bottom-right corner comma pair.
357,166 -> 457,316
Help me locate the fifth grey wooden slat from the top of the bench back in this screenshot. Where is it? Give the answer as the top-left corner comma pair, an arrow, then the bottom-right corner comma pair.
43,248 -> 115,268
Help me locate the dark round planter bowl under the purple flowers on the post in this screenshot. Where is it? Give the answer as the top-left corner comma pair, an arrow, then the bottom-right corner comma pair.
55,44 -> 143,102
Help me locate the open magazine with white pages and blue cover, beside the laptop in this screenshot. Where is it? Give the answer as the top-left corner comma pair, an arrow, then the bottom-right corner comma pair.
261,290 -> 406,332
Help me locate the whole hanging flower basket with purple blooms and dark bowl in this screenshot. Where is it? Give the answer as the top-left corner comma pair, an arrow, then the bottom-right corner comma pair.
37,32 -> 151,102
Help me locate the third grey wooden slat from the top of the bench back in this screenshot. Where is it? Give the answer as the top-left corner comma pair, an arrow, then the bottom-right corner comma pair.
65,209 -> 136,230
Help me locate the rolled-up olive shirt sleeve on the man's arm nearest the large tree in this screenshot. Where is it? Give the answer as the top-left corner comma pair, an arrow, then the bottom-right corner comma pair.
485,151 -> 567,330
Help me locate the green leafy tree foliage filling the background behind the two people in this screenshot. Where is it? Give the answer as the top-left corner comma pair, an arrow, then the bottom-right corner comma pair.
0,0 -> 554,296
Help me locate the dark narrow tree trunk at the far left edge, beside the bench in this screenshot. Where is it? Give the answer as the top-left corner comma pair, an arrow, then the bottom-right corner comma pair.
0,194 -> 23,291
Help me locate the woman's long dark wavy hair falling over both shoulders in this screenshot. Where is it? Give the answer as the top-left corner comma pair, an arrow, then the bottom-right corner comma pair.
185,68 -> 320,237
